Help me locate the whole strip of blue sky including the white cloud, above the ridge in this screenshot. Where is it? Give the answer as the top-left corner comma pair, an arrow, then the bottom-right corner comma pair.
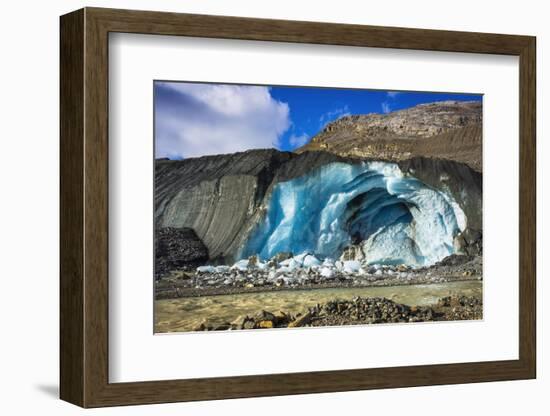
154,81 -> 482,159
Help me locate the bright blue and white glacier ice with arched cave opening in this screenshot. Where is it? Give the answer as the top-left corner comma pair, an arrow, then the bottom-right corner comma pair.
240,161 -> 466,266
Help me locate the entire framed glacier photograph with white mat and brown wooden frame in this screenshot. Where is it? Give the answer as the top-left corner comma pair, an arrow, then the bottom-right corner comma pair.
60,8 -> 536,407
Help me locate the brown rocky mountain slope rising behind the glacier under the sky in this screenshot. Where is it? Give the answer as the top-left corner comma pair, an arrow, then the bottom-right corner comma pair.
297,101 -> 482,172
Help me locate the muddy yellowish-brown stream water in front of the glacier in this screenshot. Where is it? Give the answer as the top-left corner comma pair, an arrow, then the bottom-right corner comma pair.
155,281 -> 482,332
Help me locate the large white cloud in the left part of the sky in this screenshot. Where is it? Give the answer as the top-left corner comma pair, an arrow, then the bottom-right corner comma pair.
155,82 -> 290,158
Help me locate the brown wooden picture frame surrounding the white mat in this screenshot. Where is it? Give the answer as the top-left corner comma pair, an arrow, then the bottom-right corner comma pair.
60,8 -> 536,407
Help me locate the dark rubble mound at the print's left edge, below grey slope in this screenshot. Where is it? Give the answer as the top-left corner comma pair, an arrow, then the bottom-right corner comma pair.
155,227 -> 208,278
